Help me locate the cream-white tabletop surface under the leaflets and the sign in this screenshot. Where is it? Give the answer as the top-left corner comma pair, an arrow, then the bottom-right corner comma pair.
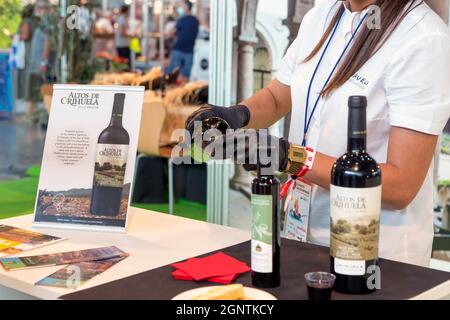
0,208 -> 250,300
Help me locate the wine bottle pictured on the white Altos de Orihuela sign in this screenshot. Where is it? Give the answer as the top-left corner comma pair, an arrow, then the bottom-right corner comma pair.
91,93 -> 130,216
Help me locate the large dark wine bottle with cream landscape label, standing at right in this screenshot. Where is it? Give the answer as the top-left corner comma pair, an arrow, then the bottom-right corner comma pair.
330,96 -> 381,294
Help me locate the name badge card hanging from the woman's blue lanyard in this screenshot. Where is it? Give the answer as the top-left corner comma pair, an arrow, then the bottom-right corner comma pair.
284,178 -> 312,242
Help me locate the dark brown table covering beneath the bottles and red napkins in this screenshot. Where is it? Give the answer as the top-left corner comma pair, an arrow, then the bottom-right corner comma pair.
62,239 -> 450,300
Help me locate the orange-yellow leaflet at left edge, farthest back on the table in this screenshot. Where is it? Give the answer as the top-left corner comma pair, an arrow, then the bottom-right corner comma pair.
0,224 -> 64,257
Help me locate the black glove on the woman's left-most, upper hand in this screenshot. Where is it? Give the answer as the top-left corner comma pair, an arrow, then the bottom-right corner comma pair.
186,104 -> 250,135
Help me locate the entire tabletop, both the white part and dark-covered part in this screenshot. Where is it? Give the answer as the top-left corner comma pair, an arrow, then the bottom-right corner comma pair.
0,208 -> 450,300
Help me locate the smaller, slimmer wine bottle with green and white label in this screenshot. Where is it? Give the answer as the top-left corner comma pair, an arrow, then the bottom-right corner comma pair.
251,165 -> 280,288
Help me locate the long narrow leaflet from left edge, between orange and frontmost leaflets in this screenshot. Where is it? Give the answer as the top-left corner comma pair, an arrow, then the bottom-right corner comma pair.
0,246 -> 125,271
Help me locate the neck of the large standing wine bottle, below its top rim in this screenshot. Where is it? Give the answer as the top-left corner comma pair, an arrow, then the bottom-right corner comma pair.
347,108 -> 367,153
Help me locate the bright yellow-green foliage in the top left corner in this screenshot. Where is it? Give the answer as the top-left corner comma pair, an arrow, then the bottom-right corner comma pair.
0,0 -> 21,49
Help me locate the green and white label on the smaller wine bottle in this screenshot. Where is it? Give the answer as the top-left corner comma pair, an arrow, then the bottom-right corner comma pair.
252,194 -> 273,273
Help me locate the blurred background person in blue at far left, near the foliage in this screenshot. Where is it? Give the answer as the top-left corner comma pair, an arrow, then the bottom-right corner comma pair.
25,0 -> 51,116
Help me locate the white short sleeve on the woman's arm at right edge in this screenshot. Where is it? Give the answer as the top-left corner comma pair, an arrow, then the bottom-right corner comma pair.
385,34 -> 450,135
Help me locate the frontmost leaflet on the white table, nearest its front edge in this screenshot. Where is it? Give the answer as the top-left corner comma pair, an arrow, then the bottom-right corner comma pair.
36,253 -> 129,289
